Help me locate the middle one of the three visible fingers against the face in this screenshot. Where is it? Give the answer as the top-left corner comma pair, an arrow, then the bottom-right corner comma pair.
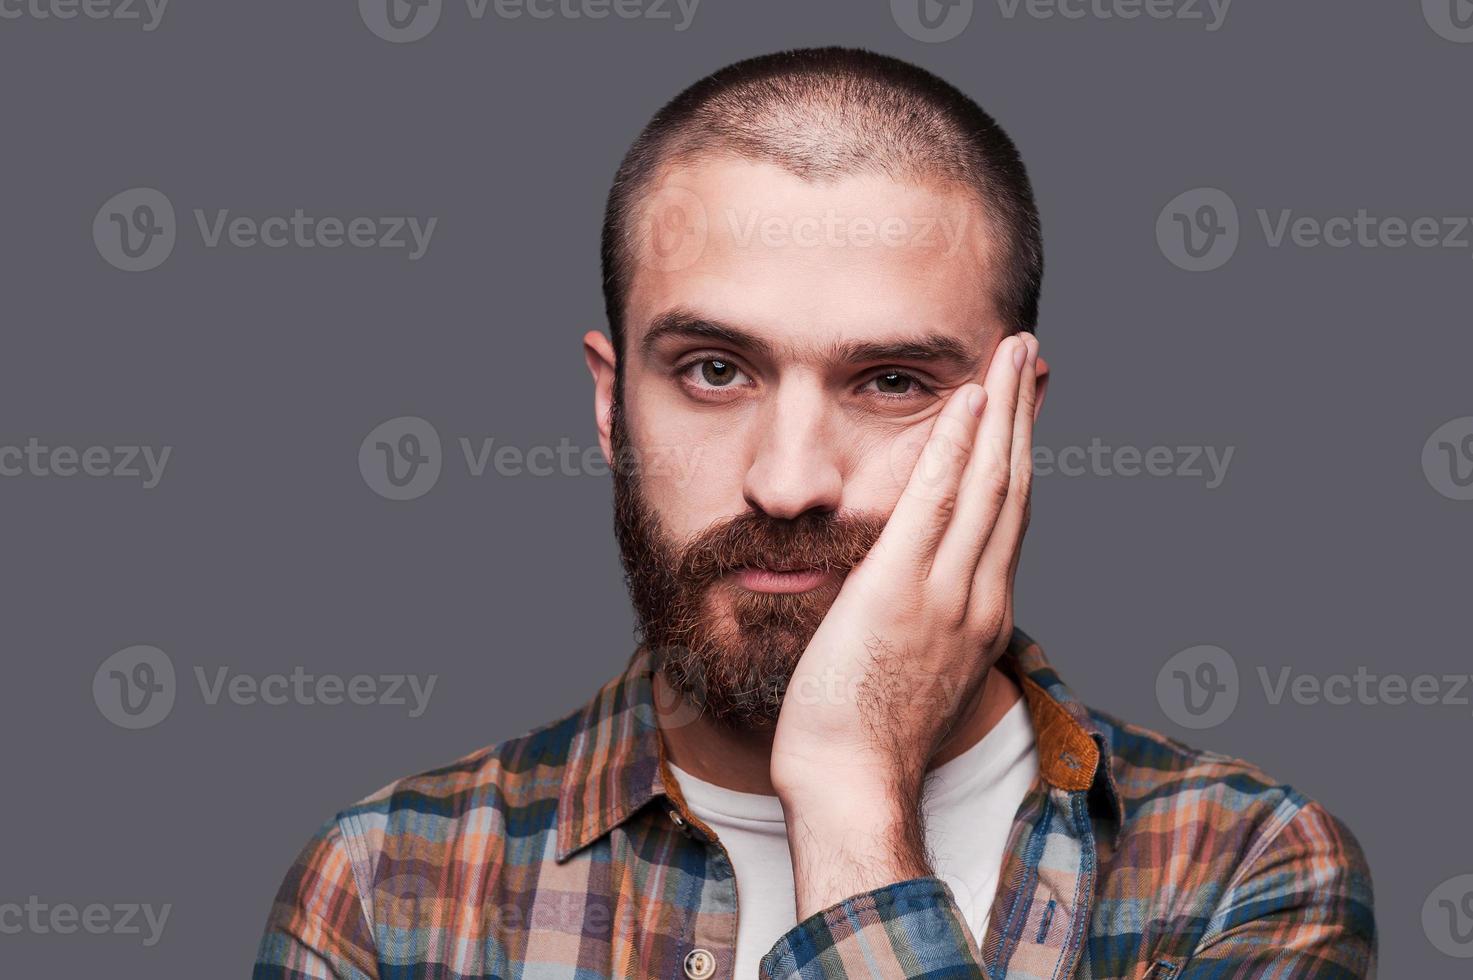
931,337 -> 1028,589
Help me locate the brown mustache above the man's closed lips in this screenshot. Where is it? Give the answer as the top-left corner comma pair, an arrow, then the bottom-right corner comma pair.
676,510 -> 887,584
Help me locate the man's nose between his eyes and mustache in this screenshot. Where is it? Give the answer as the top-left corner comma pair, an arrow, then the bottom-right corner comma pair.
742,382 -> 844,520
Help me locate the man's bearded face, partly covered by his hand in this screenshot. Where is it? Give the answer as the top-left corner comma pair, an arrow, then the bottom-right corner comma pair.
589,158 -> 1006,727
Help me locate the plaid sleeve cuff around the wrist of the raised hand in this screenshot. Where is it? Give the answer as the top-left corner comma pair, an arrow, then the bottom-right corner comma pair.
762,875 -> 982,980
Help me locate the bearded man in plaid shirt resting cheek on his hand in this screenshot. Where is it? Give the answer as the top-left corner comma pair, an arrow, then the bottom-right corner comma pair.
255,49 -> 1376,980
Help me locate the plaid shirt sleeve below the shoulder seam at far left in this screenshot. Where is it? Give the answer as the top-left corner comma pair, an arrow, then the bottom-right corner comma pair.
250,819 -> 379,980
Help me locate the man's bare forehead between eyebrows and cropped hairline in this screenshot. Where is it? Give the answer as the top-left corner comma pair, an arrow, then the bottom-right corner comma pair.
626,156 -> 1003,359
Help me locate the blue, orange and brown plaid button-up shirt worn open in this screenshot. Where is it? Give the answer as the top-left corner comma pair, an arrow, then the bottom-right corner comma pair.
255,631 -> 1376,980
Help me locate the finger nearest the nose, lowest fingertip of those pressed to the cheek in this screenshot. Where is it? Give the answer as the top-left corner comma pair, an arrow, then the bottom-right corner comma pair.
875,385 -> 988,570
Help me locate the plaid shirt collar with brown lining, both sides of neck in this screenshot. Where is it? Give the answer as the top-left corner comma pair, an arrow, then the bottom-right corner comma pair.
557,629 -> 1124,862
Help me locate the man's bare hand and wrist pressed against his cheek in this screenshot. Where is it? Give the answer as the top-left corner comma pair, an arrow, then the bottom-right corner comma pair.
770,335 -> 1037,918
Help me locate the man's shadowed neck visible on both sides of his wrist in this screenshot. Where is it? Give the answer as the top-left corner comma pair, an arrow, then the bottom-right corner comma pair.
654,657 -> 1022,796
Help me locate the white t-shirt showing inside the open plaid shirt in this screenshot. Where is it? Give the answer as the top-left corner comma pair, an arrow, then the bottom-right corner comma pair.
670,699 -> 1038,977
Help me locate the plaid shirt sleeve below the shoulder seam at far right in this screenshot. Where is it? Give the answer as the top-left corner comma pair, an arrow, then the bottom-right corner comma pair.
1150,802 -> 1376,980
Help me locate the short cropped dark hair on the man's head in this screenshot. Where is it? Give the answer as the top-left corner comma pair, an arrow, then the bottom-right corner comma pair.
601,47 -> 1043,376
